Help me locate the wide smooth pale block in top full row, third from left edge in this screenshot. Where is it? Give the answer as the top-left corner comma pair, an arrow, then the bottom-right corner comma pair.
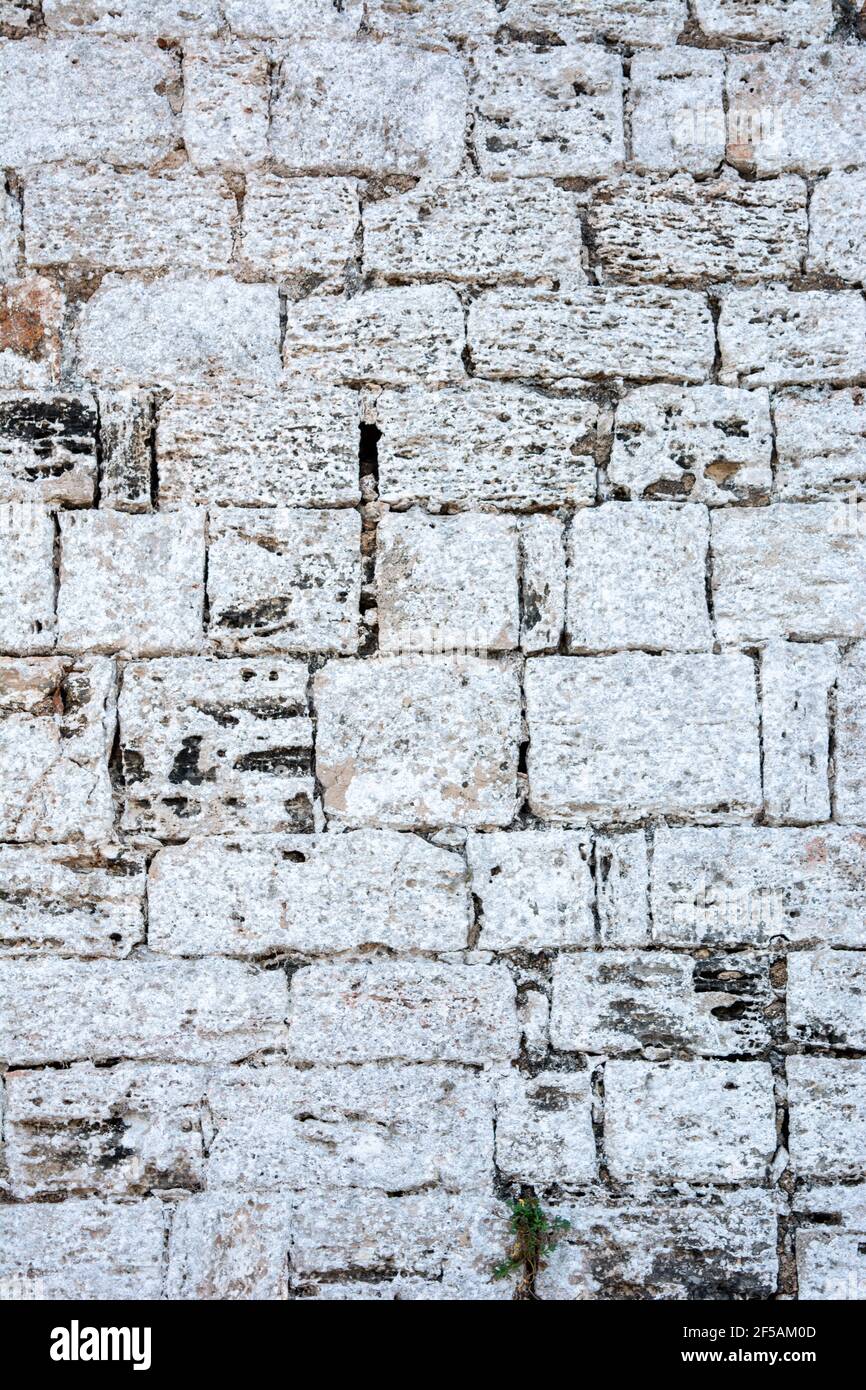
270,40 -> 466,178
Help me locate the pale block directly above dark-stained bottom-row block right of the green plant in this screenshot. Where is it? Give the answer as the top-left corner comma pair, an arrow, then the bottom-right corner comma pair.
605,1062 -> 776,1183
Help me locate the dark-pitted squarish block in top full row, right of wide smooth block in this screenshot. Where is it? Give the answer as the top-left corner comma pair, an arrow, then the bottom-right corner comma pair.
473,44 -> 626,178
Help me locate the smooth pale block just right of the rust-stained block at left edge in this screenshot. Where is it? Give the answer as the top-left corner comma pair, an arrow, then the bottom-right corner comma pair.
78,275 -> 279,386
